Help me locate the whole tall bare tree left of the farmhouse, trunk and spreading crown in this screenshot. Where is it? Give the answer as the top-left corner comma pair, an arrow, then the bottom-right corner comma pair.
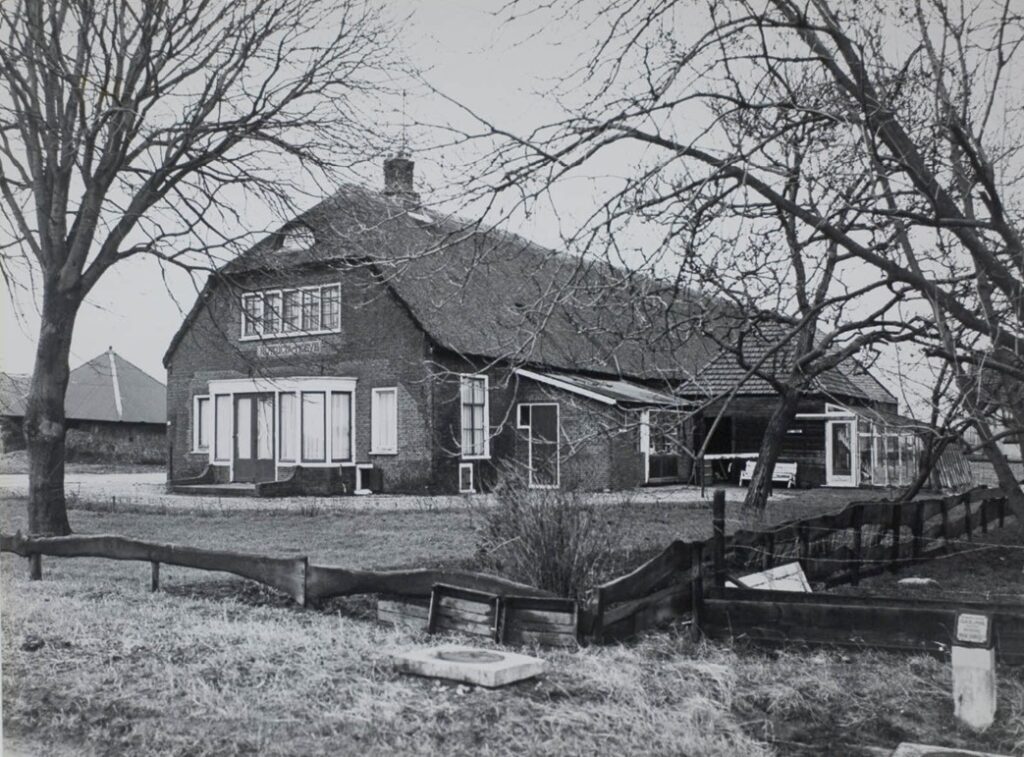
0,0 -> 397,534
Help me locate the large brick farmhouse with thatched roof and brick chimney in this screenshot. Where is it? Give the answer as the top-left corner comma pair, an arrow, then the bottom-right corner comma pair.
164,157 -> 921,496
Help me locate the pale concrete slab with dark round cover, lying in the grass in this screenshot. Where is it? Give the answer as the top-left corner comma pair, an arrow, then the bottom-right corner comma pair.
393,644 -> 548,688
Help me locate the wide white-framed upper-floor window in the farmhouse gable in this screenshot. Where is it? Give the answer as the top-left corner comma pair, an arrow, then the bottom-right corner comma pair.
242,284 -> 341,339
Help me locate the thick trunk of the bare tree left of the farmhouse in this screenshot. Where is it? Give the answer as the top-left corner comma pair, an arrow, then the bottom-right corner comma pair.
25,282 -> 80,536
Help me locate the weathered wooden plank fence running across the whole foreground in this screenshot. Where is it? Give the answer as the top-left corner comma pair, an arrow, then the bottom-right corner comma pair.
0,490 -> 1024,662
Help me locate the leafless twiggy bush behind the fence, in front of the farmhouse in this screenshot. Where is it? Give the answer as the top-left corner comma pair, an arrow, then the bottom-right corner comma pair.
477,476 -> 611,597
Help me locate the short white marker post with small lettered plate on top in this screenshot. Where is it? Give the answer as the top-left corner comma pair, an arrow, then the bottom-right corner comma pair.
952,613 -> 995,730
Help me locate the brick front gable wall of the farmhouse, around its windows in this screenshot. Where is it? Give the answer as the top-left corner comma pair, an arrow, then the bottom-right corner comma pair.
167,269 -> 433,493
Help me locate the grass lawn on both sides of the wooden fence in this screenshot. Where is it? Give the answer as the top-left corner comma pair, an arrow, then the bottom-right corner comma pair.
6,493 -> 1024,756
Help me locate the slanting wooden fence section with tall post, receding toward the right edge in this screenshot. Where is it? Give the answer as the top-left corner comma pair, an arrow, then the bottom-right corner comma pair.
584,490 -> 1016,641
